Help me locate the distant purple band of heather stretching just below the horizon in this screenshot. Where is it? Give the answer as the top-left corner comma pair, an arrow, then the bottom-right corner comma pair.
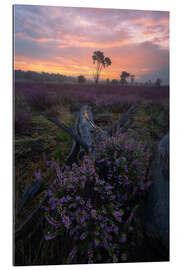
15,82 -> 169,112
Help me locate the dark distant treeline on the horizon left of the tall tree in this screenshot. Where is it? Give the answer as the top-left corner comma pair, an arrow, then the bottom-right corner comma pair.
14,70 -> 77,83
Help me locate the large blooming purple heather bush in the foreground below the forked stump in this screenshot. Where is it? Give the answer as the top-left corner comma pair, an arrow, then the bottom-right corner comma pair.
45,134 -> 151,263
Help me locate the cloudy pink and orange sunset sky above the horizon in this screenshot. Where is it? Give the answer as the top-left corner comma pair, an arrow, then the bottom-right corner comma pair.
14,5 -> 169,84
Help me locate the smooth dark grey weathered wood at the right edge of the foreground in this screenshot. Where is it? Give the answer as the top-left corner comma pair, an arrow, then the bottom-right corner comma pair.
139,134 -> 169,260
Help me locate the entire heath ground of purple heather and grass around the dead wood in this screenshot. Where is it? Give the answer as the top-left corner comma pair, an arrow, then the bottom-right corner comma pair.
14,81 -> 169,265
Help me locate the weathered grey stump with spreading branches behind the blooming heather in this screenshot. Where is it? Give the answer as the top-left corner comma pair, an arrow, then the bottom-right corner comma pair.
47,104 -> 138,163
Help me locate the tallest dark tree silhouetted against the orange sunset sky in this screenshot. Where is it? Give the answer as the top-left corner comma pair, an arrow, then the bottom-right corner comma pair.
92,51 -> 112,84
